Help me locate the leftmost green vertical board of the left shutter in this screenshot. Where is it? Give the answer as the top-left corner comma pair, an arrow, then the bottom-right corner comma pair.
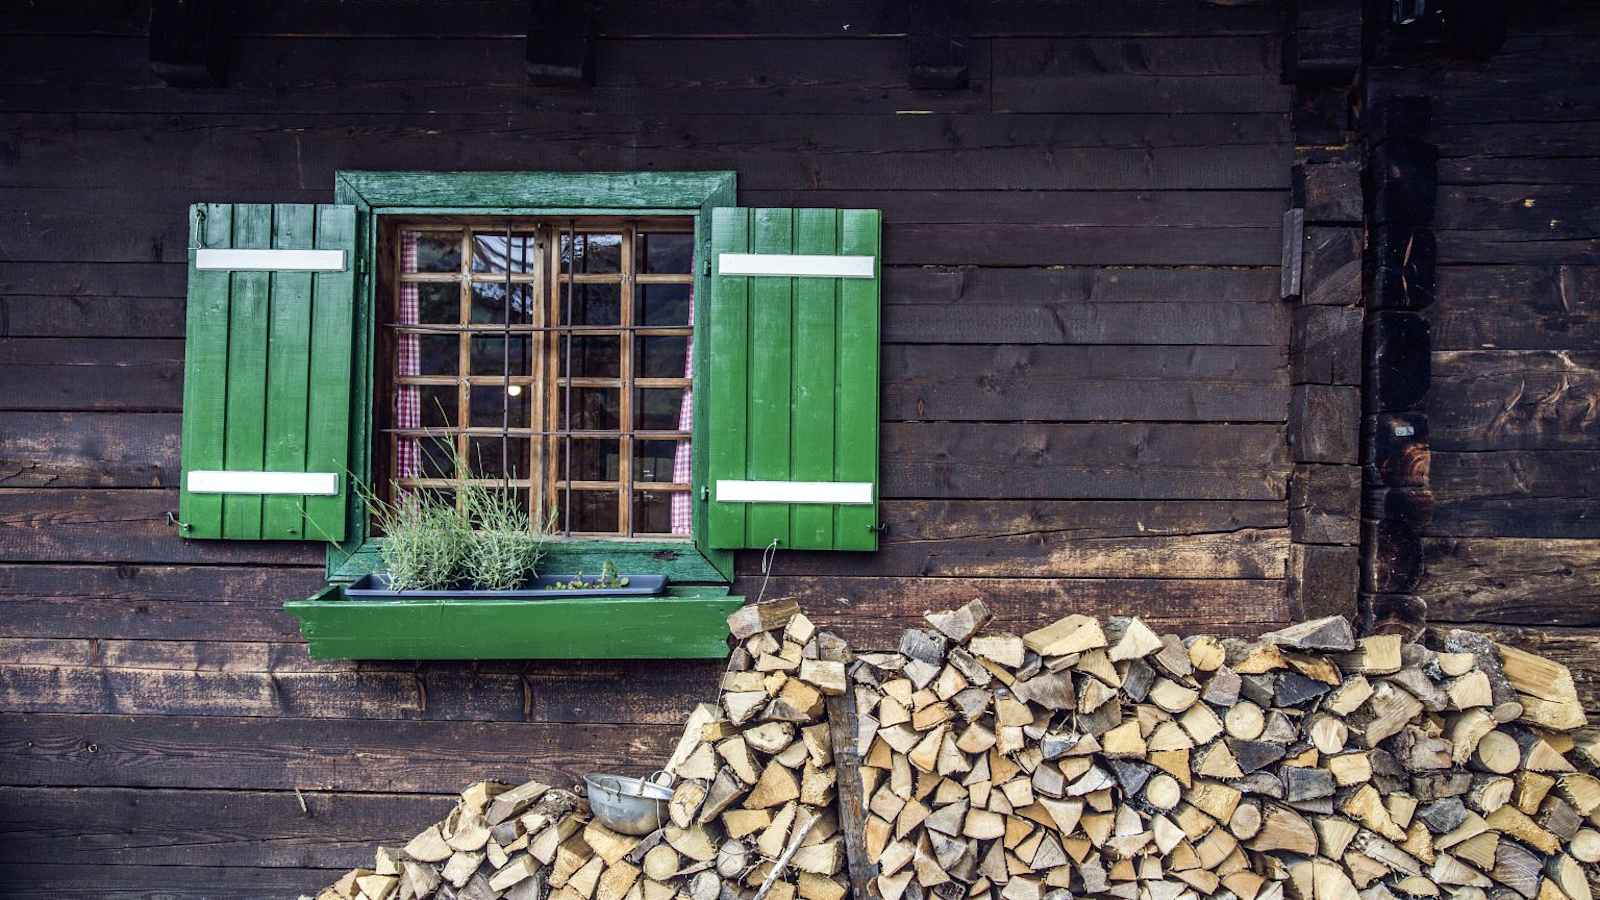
178,203 -> 234,538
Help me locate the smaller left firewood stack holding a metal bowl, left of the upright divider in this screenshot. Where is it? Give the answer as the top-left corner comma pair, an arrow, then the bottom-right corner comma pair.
318,602 -> 848,900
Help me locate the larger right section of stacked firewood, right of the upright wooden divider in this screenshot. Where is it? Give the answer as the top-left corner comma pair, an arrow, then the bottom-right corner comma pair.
851,601 -> 1600,900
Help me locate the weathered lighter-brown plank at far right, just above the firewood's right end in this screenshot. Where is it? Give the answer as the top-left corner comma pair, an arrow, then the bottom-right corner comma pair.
1419,538 -> 1600,628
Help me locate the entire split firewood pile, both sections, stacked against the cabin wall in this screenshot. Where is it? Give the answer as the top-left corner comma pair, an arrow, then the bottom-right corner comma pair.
318,601 -> 1600,900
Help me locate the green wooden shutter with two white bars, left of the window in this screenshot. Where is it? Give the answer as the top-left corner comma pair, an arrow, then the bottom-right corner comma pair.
178,203 -> 355,541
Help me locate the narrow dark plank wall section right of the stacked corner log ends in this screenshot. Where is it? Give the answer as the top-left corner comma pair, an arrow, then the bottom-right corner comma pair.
1370,2 -> 1600,711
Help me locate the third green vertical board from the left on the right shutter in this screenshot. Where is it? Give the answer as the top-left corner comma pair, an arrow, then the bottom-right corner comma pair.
789,210 -> 840,549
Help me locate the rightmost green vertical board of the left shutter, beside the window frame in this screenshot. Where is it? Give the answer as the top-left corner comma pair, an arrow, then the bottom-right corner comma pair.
304,205 -> 362,541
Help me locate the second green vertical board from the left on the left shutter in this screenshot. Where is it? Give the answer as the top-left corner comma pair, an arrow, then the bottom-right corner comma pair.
222,203 -> 272,541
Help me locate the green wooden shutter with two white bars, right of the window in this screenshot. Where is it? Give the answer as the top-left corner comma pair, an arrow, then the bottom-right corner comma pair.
702,208 -> 882,549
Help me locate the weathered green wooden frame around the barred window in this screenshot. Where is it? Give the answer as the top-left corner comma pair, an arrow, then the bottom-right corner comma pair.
328,171 -> 736,585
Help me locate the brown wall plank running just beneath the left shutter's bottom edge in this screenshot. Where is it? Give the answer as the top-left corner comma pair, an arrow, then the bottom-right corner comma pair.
0,488 -> 325,565
